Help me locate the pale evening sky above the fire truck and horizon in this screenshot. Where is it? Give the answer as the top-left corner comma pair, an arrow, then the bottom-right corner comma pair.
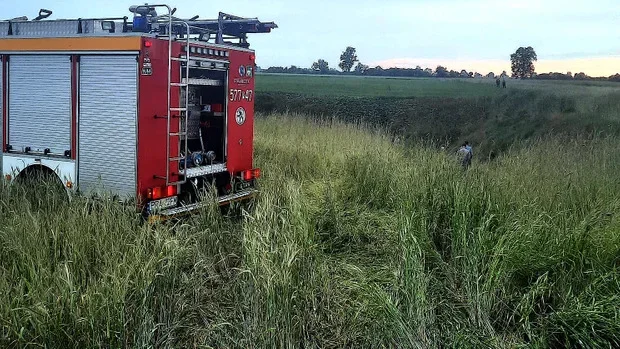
0,0 -> 620,76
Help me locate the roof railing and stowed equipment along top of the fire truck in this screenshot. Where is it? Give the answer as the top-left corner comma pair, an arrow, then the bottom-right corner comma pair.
0,4 -> 278,47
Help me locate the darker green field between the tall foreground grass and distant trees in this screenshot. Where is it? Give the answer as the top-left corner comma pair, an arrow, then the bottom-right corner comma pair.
256,74 -> 620,158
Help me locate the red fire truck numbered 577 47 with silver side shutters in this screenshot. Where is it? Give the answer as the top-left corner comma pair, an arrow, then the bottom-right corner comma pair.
0,4 -> 277,217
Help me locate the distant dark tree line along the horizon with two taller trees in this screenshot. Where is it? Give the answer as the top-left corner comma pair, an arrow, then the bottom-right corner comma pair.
257,46 -> 620,82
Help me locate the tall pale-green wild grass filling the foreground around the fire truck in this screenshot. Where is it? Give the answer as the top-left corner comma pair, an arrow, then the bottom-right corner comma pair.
0,115 -> 620,348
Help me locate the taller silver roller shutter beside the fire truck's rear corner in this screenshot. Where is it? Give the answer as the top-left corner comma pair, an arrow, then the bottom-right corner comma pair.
78,56 -> 138,197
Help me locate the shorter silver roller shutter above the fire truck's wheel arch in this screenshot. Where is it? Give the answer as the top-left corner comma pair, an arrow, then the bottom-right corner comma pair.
9,55 -> 71,155
